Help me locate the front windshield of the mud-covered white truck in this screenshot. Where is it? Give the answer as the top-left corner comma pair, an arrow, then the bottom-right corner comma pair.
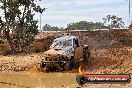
51,40 -> 72,48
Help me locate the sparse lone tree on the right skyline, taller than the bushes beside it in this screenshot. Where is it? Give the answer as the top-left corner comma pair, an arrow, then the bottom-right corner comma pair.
103,15 -> 125,28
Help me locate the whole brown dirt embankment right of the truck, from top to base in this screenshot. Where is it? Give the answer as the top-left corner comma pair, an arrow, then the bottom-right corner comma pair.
70,30 -> 132,74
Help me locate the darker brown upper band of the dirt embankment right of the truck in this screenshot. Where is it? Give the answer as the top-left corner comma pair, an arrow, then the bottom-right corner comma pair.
72,30 -> 132,49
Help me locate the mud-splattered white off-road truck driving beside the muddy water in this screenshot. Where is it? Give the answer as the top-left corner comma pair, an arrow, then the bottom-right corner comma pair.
41,33 -> 90,71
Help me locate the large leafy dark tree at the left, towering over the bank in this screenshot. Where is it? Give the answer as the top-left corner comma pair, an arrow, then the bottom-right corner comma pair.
0,0 -> 45,52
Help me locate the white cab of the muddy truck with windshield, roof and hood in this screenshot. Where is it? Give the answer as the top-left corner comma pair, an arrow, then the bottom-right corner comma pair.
45,36 -> 79,58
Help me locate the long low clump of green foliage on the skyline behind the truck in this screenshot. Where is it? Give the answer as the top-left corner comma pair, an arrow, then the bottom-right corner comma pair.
66,21 -> 105,31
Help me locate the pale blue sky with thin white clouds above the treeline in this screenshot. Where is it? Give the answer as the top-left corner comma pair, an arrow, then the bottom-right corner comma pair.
35,0 -> 132,27
